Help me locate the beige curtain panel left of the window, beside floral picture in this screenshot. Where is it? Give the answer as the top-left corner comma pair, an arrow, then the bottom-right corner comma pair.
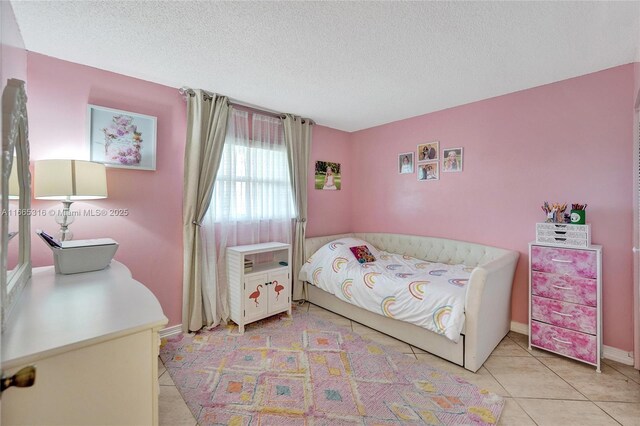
182,89 -> 229,332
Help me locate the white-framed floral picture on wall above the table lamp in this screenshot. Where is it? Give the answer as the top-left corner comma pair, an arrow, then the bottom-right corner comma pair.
87,105 -> 157,170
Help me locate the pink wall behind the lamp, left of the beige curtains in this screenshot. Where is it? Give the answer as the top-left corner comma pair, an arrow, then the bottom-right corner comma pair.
28,53 -> 186,325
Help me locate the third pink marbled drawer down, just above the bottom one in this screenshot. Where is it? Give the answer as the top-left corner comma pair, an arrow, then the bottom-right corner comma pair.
531,296 -> 597,334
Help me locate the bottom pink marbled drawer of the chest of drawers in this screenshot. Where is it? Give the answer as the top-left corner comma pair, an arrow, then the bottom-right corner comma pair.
531,321 -> 598,364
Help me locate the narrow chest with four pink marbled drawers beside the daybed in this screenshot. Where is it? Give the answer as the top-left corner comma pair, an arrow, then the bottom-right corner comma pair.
529,243 -> 602,372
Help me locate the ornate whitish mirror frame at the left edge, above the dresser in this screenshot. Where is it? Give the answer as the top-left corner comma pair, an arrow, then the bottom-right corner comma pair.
0,79 -> 31,329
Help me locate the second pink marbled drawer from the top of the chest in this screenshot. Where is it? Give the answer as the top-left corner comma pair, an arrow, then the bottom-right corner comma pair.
531,271 -> 598,306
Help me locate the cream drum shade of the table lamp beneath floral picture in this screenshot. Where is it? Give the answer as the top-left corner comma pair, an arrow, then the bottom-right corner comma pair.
34,160 -> 107,201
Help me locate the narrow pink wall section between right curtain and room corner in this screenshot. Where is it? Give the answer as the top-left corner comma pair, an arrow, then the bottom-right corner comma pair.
307,126 -> 355,237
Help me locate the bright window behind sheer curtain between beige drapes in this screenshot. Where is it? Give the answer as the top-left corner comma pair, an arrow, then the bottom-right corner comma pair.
210,109 -> 294,222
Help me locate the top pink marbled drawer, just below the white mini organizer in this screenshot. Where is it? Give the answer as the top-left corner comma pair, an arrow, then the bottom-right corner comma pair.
531,246 -> 598,278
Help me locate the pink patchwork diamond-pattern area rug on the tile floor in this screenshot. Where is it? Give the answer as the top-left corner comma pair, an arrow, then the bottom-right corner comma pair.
160,310 -> 504,426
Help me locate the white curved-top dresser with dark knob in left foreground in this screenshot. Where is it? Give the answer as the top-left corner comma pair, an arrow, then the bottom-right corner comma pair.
2,261 -> 167,426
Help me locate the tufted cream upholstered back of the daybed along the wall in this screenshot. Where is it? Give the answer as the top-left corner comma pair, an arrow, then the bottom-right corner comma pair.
305,232 -> 517,267
